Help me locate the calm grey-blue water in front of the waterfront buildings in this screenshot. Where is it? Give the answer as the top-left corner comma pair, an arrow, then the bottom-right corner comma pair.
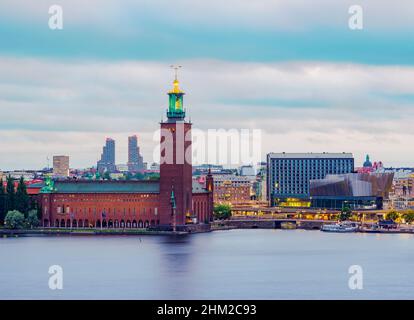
0,229 -> 414,299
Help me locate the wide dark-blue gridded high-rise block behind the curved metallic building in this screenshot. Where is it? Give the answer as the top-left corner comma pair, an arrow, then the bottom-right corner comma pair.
267,153 -> 354,207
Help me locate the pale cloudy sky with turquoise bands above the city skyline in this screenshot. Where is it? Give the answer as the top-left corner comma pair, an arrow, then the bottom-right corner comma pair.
0,0 -> 414,171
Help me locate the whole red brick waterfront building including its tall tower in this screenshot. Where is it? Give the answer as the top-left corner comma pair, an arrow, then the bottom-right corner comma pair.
40,78 -> 213,229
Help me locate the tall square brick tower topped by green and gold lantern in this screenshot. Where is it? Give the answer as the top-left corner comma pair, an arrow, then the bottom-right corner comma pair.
159,68 -> 192,228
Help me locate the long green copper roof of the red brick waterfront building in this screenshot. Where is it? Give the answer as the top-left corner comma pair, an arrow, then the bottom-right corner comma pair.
47,181 -> 160,193
